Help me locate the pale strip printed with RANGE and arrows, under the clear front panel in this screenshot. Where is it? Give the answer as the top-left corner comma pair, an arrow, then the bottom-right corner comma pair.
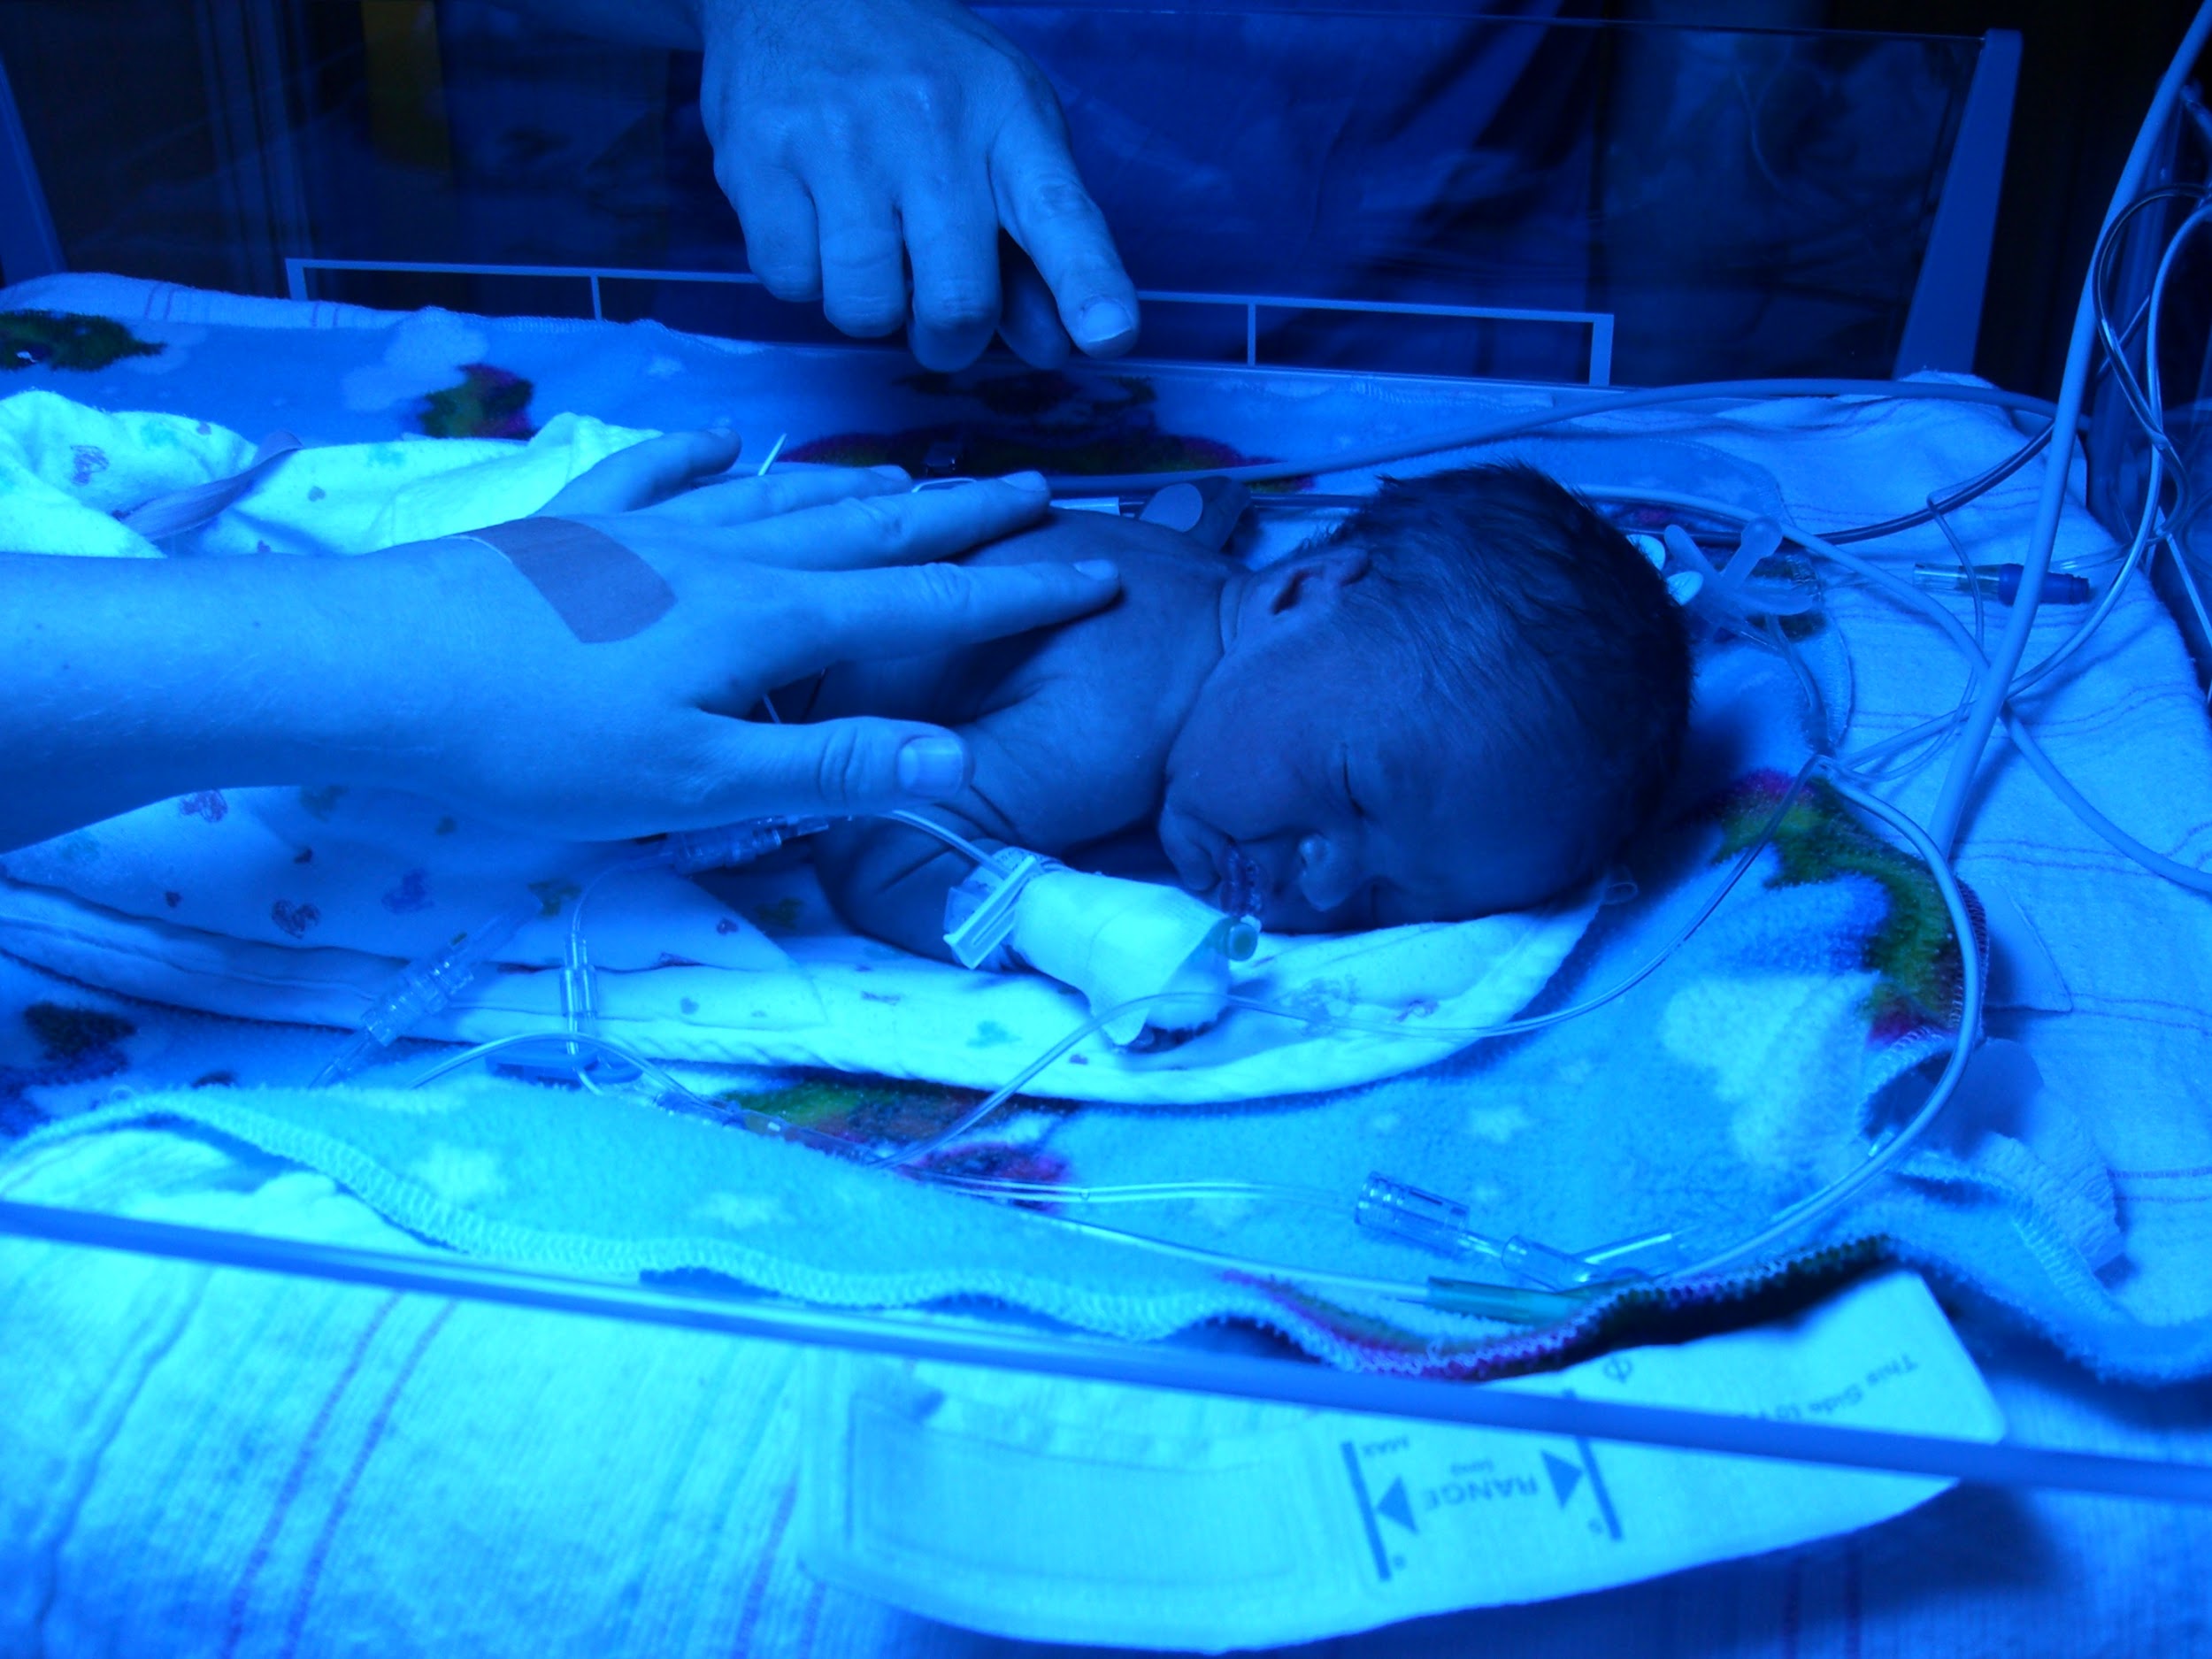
803,1272 -> 2004,1648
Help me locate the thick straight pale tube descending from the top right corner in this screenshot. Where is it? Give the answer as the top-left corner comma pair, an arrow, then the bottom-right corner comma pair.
1929,0 -> 2212,856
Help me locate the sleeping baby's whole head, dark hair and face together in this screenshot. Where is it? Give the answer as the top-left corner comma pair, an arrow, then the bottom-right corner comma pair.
1159,465 -> 1690,932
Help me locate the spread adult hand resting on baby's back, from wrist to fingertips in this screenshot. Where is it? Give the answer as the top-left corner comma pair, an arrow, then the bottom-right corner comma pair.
385,434 -> 1118,839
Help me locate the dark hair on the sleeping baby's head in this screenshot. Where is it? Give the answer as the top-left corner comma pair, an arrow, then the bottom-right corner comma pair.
1325,463 -> 1690,885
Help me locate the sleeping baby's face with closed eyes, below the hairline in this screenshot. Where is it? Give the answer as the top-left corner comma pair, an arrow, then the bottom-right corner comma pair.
1159,584 -> 1566,933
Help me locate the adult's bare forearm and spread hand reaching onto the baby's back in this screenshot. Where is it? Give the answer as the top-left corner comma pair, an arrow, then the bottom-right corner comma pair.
0,434 -> 1118,849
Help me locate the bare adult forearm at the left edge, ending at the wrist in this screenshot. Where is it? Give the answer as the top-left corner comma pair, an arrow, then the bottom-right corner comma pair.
0,556 -> 427,849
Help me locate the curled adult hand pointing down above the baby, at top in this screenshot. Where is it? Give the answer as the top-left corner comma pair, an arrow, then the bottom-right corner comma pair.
697,0 -> 1137,370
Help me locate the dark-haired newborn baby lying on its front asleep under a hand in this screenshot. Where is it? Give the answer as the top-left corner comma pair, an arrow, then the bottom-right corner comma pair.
805,465 -> 1690,960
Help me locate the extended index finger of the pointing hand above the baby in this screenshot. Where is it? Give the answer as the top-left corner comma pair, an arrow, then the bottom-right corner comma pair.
991,111 -> 1137,357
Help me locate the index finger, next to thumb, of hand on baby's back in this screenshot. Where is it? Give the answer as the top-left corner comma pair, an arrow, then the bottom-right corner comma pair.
764,546 -> 1122,684
